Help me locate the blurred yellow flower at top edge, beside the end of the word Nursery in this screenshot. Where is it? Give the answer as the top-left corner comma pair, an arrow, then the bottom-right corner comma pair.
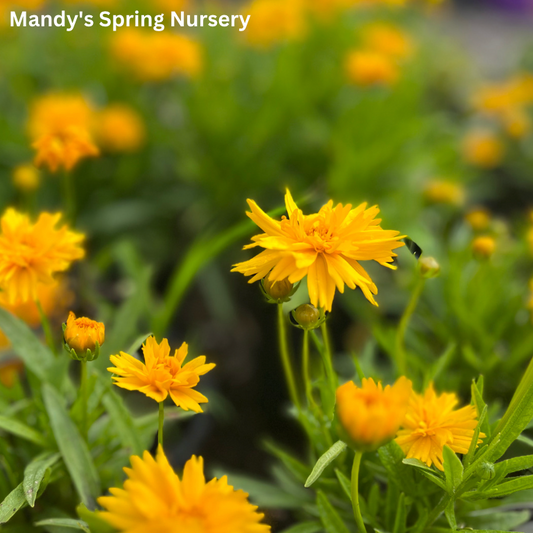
242,0 -> 306,48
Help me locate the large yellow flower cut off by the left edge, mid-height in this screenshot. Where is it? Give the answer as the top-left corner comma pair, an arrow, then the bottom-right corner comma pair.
0,208 -> 85,303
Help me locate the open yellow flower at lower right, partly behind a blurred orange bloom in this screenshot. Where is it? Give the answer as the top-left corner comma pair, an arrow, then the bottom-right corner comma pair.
396,384 -> 485,470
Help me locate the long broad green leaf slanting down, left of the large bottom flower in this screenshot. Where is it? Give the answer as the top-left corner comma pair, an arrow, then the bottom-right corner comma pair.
43,384 -> 100,507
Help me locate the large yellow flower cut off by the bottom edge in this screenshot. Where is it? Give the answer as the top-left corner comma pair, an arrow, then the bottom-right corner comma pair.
98,446 -> 270,533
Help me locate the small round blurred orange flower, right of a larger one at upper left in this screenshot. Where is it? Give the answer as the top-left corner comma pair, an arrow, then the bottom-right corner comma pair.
95,104 -> 145,152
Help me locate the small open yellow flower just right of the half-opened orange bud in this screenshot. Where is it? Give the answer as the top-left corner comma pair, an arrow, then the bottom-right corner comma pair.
108,337 -> 215,413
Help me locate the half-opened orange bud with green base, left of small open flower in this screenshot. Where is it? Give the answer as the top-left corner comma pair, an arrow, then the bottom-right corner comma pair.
63,311 -> 105,361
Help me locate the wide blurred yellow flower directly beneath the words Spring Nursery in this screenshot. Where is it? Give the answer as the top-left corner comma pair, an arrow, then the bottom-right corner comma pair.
111,28 -> 202,81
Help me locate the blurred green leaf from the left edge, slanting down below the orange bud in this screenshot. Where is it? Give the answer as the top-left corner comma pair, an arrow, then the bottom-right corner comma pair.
0,308 -> 54,381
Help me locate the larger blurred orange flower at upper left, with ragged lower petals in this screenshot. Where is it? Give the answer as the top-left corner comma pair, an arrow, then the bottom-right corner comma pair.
28,94 -> 99,172
